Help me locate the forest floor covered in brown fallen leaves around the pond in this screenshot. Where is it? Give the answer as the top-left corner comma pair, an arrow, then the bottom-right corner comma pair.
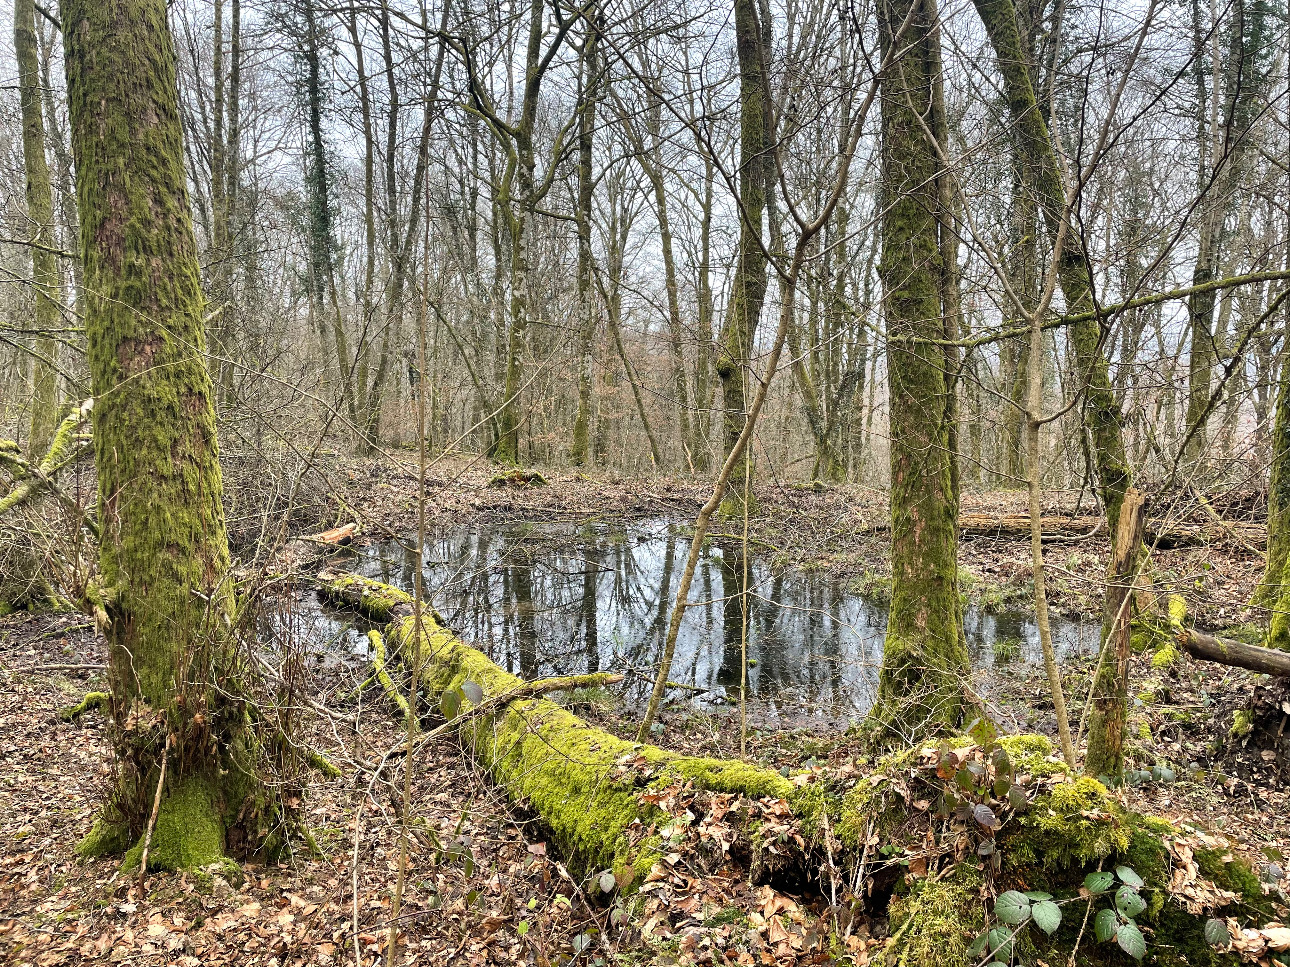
0,462 -> 1290,967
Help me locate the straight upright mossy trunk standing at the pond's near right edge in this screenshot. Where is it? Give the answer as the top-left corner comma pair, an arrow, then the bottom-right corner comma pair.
876,0 -> 968,734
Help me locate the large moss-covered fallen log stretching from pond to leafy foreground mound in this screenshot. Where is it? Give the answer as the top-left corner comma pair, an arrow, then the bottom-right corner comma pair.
324,575 -> 1272,966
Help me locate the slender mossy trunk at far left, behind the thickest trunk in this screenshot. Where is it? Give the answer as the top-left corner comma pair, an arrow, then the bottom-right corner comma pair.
13,0 -> 59,460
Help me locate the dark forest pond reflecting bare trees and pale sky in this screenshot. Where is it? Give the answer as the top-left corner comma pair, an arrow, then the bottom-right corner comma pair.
298,520 -> 1098,718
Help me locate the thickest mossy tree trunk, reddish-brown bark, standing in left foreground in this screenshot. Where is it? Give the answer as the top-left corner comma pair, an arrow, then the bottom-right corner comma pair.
62,0 -> 267,868
